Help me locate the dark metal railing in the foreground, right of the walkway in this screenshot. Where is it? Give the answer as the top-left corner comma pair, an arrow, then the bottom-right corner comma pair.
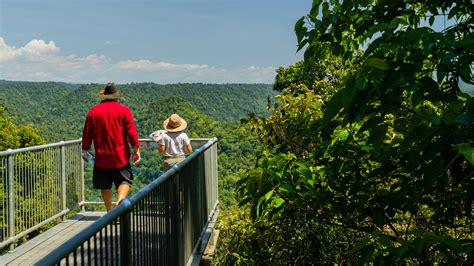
37,138 -> 218,265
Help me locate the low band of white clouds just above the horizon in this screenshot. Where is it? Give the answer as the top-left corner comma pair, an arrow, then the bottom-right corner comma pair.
0,37 -> 275,83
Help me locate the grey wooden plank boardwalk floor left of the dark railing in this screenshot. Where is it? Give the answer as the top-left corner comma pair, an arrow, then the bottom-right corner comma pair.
0,212 -> 105,265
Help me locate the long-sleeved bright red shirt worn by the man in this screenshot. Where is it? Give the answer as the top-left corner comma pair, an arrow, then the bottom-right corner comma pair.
82,100 -> 140,168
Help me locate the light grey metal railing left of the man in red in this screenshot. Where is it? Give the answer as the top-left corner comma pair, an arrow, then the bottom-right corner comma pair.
0,139 -> 84,249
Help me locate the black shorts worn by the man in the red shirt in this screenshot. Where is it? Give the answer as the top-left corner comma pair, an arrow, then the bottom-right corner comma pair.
92,164 -> 133,189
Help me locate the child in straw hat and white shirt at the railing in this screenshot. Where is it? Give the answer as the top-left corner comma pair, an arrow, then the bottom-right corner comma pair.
158,114 -> 193,171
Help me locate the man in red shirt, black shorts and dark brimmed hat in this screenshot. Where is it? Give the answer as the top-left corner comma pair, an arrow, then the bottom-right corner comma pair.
82,83 -> 140,211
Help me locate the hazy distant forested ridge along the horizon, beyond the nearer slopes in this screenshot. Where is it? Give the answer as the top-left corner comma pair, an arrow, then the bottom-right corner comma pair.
0,80 -> 276,142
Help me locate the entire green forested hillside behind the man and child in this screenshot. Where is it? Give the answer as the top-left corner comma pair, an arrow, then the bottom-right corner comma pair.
0,81 -> 276,208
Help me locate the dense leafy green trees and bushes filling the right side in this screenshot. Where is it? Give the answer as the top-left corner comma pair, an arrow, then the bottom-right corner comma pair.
223,0 -> 474,265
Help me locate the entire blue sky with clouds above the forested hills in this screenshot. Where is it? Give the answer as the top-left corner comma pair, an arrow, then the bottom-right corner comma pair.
0,0 -> 311,84
